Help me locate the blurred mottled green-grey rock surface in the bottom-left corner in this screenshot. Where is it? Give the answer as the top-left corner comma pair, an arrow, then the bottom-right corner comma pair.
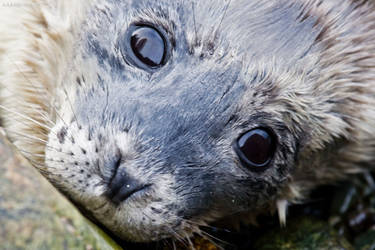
0,132 -> 121,250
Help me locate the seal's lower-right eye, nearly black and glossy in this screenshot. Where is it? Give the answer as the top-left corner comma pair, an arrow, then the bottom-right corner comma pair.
234,128 -> 275,170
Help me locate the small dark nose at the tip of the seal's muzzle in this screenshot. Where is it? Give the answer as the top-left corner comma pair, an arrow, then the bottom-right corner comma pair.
105,166 -> 151,205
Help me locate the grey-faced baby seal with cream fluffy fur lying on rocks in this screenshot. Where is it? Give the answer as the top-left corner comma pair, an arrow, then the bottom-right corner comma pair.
0,0 -> 375,242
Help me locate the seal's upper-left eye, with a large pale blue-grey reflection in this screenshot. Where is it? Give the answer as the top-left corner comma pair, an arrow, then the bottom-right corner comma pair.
130,26 -> 166,68
